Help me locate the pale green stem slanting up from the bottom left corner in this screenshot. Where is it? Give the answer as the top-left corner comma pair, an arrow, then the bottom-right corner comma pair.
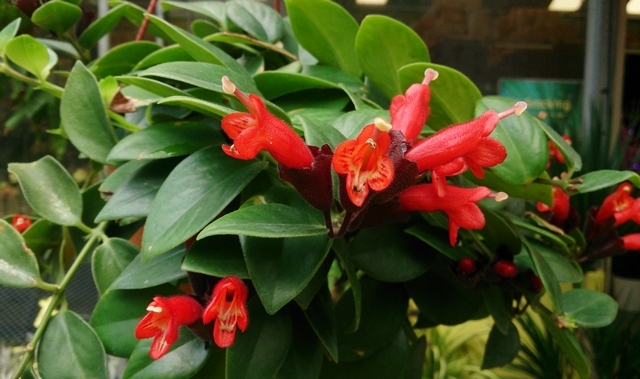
12,221 -> 107,379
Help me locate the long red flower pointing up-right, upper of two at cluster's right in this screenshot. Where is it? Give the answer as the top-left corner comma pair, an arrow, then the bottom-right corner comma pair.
405,101 -> 527,196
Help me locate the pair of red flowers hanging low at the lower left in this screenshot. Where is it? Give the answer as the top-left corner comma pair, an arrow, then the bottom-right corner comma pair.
135,276 -> 249,359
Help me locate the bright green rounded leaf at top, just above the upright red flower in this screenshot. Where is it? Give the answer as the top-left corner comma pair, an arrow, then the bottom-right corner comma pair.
356,15 -> 430,99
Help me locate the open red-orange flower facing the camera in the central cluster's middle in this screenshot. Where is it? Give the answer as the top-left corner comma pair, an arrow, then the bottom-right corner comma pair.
332,118 -> 394,207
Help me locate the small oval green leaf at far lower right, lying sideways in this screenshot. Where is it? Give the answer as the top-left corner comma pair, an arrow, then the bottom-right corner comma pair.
562,288 -> 618,328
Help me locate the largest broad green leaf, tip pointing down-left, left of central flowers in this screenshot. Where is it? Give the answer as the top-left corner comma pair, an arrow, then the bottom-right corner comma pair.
142,146 -> 264,260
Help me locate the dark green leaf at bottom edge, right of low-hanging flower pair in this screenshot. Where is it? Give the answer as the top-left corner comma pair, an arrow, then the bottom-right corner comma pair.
226,297 -> 292,379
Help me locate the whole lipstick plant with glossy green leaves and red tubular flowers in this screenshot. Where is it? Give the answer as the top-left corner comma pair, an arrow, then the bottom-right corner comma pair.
0,0 -> 640,379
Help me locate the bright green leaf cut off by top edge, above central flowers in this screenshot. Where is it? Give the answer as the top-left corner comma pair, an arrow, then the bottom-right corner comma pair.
285,0 -> 362,77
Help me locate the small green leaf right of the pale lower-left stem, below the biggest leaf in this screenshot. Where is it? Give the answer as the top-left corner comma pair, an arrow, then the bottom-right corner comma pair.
91,238 -> 140,294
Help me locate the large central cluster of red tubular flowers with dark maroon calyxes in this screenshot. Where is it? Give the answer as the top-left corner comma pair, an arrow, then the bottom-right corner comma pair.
222,69 -> 526,245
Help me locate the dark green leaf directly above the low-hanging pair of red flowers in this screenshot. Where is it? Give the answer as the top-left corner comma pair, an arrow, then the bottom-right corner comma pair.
182,236 -> 249,279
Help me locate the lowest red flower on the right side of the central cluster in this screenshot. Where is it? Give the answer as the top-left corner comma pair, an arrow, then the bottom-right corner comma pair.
399,184 -> 506,246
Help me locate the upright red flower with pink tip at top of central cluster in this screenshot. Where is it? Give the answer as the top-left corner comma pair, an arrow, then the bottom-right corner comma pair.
389,68 -> 438,142
